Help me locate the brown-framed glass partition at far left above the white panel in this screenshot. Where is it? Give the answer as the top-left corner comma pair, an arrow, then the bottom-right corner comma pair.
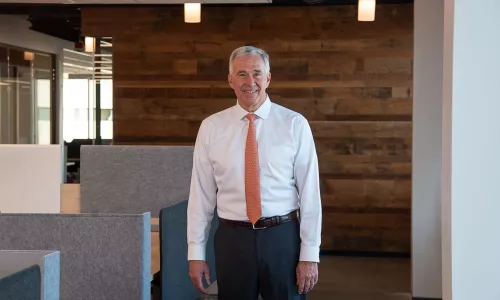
0,44 -> 55,144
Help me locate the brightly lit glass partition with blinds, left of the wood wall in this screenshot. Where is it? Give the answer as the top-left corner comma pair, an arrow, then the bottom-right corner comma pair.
63,38 -> 113,144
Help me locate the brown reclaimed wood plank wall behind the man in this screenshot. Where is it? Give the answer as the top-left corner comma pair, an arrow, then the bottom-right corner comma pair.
82,5 -> 413,253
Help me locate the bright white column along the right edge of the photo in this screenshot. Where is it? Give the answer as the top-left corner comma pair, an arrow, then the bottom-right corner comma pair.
442,0 -> 500,300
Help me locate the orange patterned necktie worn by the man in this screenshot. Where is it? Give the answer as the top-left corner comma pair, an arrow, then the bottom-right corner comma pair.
245,114 -> 262,225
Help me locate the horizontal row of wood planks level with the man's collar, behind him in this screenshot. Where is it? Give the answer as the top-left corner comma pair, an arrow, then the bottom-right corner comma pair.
115,96 -> 412,122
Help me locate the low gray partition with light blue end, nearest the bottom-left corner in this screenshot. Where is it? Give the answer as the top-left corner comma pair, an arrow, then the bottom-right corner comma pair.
0,250 -> 61,300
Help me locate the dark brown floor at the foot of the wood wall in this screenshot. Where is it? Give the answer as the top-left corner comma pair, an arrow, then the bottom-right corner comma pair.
307,256 -> 411,300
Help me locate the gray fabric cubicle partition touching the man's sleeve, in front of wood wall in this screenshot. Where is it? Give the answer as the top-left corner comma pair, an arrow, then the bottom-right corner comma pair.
80,146 -> 194,218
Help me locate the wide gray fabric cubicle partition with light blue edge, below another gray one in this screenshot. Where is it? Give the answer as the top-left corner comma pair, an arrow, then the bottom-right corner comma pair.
0,213 -> 151,300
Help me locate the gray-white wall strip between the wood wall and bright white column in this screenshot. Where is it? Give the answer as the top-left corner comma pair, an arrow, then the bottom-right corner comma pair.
412,0 -> 444,298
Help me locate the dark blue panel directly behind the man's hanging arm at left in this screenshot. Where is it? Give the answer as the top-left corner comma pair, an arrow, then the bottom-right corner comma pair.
160,201 -> 219,300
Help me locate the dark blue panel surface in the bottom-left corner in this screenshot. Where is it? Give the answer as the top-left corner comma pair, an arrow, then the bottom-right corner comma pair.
0,265 -> 41,300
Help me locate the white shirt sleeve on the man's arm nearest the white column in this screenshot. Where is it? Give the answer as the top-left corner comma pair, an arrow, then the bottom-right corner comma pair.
294,116 -> 322,262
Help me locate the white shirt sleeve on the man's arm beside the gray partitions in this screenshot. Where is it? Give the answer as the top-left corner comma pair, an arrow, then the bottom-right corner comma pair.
187,119 -> 217,260
